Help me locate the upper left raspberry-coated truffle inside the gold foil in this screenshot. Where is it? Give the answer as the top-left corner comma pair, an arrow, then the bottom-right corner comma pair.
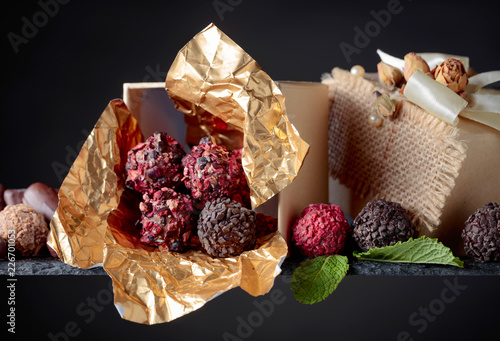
125,132 -> 186,193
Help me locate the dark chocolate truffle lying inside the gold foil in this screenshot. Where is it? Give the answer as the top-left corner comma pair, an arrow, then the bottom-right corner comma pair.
198,198 -> 256,258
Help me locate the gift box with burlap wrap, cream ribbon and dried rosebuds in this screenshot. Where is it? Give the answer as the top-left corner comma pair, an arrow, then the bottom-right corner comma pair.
322,50 -> 500,256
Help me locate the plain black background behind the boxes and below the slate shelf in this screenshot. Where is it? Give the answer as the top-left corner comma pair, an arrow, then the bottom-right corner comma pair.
0,0 -> 500,340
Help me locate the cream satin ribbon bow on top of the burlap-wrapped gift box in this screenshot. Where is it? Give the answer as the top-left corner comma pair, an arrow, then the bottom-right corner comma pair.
377,50 -> 500,131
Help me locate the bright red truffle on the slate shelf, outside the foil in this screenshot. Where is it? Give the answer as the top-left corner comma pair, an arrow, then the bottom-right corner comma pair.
292,204 -> 350,257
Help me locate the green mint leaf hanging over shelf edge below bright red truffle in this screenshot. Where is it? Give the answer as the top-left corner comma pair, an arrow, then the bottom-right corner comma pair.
291,255 -> 349,304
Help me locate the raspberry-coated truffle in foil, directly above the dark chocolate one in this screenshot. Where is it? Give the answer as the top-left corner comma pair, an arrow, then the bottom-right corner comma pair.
182,137 -> 233,204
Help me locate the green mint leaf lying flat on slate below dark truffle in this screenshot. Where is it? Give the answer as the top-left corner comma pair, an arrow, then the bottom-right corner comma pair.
353,236 -> 464,268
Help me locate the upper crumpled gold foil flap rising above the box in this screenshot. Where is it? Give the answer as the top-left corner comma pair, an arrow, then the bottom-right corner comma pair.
165,24 -> 309,208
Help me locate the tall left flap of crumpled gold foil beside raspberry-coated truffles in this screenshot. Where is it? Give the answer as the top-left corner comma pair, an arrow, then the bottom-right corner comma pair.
48,99 -> 143,269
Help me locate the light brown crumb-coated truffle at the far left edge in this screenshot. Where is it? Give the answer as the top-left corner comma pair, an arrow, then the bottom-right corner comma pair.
0,204 -> 49,256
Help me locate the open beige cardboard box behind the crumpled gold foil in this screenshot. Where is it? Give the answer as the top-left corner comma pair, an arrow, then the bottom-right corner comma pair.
123,81 -> 329,255
